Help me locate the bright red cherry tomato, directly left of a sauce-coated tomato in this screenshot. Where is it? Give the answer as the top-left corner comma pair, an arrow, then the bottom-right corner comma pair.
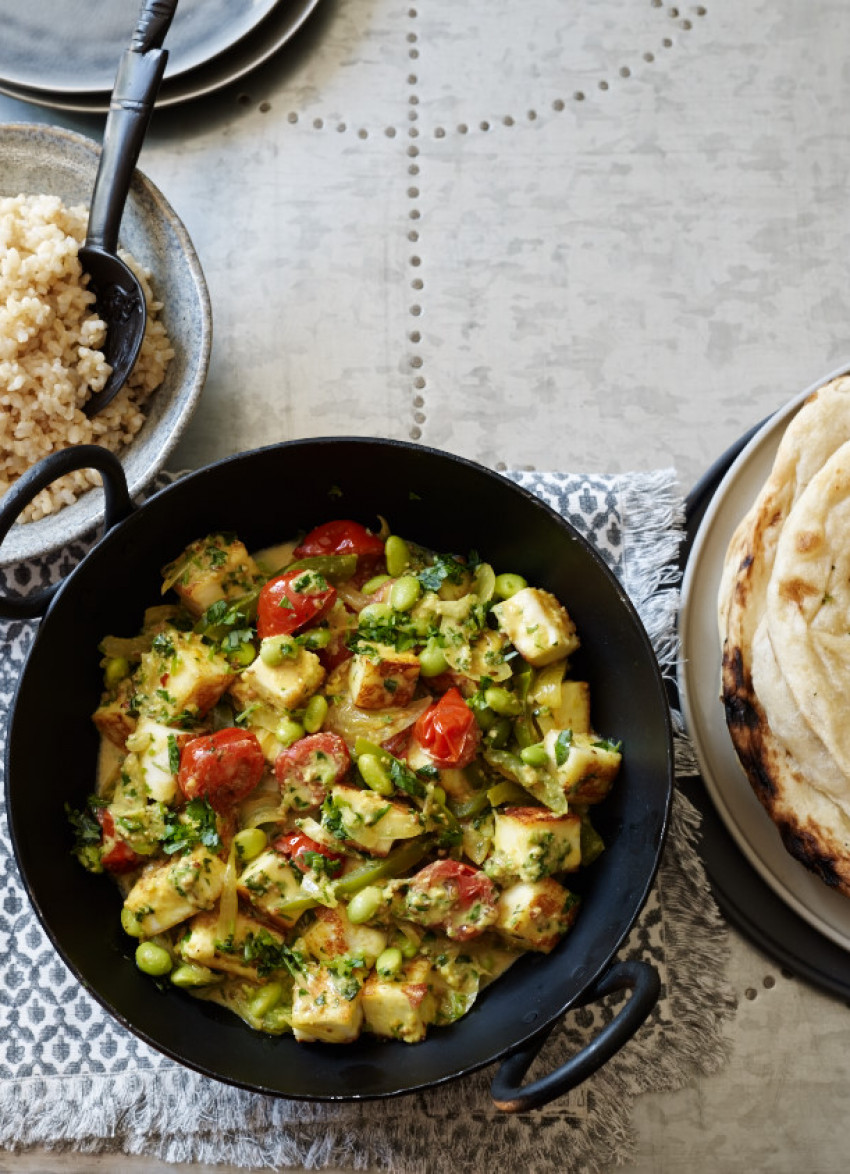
177,728 -> 265,814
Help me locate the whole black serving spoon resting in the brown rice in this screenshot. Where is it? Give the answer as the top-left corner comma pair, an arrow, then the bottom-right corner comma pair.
79,0 -> 177,416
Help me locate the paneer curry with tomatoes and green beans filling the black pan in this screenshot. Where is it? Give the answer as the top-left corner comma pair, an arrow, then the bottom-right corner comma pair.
69,520 -> 621,1044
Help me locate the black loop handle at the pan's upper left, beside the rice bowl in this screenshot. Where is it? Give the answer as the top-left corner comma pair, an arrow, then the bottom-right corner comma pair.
0,444 -> 133,620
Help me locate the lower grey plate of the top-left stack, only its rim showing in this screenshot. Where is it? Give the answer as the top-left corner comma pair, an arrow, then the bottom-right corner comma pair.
0,0 -> 319,114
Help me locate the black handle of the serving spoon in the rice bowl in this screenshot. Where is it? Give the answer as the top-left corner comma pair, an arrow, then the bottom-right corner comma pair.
86,0 -> 177,252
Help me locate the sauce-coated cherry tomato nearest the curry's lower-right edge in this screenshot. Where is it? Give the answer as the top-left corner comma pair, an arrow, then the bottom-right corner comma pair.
405,861 -> 499,942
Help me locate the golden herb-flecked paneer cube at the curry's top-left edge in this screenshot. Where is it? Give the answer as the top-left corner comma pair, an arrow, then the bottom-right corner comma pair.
162,534 -> 262,616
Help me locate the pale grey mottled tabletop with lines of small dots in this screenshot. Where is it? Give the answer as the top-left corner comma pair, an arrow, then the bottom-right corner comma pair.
0,0 -> 850,1174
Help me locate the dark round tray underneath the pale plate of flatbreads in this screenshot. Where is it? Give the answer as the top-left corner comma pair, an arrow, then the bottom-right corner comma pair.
679,424 -> 850,998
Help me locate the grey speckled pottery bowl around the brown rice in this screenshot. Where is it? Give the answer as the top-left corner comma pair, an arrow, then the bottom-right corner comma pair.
0,123 -> 213,565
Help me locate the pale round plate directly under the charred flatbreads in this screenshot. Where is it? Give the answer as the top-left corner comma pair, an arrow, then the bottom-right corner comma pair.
679,365 -> 850,950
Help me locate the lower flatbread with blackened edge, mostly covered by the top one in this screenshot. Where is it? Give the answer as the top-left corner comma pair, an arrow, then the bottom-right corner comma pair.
717,376 -> 850,896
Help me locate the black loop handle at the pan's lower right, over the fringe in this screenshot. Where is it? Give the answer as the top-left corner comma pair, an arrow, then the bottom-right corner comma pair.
491,960 -> 661,1113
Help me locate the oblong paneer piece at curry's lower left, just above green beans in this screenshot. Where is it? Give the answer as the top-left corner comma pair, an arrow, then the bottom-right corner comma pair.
122,845 -> 224,938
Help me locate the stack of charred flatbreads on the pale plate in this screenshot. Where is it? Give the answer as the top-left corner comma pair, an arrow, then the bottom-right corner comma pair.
717,377 -> 850,896
